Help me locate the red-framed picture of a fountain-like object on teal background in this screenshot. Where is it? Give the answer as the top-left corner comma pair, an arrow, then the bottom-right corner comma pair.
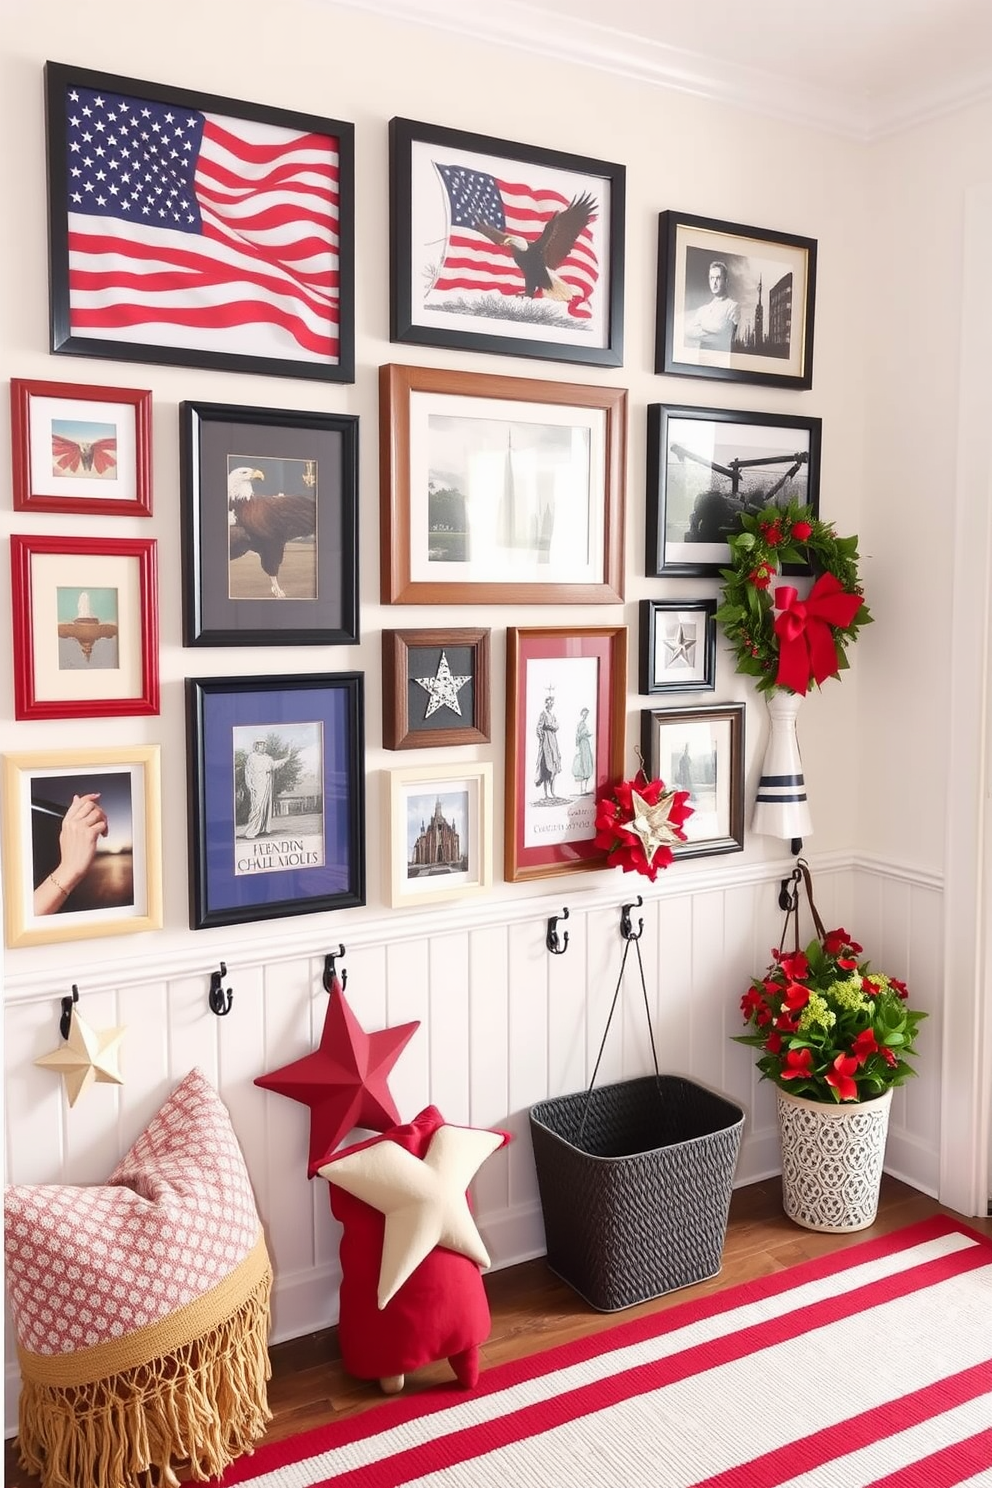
10,533 -> 159,719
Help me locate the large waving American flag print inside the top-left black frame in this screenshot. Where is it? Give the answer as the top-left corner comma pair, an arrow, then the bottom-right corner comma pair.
54,70 -> 349,375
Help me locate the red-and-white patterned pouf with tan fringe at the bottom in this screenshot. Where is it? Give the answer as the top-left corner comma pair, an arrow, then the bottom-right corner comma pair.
4,1070 -> 272,1488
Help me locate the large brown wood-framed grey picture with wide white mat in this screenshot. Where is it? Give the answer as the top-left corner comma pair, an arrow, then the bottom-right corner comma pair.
379,366 -> 626,604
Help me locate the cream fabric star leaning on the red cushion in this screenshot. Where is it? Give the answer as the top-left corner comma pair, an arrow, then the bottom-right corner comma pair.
317,1126 -> 504,1309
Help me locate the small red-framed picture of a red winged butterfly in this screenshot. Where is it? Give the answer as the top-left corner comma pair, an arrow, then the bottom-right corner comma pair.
10,378 -> 152,516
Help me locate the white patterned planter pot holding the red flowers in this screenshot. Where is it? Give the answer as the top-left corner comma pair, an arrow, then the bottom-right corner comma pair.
776,1089 -> 892,1234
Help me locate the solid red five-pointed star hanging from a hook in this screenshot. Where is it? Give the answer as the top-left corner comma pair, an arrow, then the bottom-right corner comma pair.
254,976 -> 419,1177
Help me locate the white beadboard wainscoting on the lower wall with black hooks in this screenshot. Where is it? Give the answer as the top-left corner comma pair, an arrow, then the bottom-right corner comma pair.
4,859 -> 943,1434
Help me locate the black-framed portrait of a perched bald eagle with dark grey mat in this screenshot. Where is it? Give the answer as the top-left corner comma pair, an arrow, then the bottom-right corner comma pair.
180,403 -> 360,646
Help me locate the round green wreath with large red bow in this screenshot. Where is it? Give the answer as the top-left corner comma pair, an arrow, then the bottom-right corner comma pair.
715,503 -> 873,693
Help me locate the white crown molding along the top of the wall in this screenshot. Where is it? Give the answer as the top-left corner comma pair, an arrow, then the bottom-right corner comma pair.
318,0 -> 992,143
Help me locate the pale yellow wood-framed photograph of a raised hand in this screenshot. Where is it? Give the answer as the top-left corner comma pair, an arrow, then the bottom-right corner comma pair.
3,744 -> 162,946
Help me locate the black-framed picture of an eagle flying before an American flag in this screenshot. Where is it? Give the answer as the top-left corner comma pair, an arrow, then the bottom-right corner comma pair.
390,118 -> 626,368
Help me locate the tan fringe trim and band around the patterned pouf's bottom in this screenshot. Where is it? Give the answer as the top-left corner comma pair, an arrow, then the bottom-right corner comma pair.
18,1238 -> 272,1488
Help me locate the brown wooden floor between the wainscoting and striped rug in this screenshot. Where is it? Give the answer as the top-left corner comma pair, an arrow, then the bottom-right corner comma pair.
4,1177 -> 992,1488
